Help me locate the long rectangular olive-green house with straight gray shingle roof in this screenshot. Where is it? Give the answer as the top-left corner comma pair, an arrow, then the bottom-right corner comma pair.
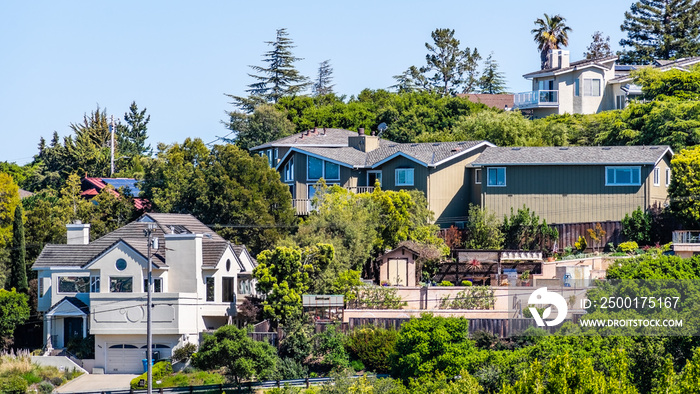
471,145 -> 673,224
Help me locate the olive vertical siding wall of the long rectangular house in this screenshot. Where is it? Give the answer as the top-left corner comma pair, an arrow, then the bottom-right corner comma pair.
482,165 -> 666,224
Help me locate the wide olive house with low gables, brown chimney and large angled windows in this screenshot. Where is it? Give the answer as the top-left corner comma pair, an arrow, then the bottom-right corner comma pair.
251,128 -> 494,226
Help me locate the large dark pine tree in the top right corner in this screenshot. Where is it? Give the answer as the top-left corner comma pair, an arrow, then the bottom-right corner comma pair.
620,0 -> 700,64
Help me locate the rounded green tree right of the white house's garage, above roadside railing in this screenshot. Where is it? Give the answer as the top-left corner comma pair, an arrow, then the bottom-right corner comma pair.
192,325 -> 277,384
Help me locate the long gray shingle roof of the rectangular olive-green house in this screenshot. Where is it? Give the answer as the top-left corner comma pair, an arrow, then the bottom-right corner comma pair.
472,145 -> 673,166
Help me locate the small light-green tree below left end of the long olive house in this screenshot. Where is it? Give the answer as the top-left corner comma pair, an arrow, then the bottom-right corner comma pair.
464,204 -> 504,249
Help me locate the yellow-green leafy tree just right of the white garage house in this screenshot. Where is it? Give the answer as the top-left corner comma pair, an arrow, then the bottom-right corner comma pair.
253,244 -> 334,324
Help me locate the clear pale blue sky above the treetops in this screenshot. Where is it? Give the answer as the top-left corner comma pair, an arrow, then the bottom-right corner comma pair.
0,0 -> 632,164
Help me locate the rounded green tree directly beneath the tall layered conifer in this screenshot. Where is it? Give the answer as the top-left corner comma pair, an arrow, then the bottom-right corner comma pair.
224,104 -> 294,150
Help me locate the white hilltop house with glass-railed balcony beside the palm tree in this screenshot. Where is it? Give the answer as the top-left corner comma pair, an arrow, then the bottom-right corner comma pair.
514,49 -> 700,118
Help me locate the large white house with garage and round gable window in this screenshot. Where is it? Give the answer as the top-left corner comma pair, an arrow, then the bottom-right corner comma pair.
33,213 -> 256,373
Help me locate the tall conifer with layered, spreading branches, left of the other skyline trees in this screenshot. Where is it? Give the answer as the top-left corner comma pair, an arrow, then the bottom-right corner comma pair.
227,28 -> 309,112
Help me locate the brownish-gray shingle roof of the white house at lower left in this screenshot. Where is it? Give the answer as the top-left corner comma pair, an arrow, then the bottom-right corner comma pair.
33,213 -> 229,268
